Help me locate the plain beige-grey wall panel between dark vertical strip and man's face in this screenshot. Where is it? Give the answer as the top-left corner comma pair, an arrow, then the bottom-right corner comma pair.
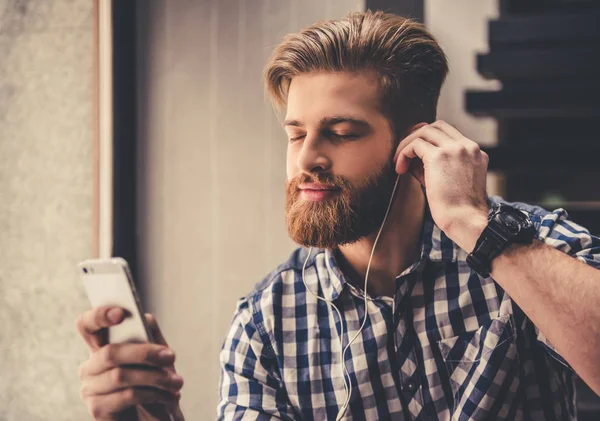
138,0 -> 364,420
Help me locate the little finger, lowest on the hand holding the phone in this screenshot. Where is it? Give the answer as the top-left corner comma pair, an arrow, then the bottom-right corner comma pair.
86,387 -> 181,419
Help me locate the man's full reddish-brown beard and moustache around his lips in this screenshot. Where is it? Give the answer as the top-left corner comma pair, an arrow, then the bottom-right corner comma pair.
286,160 -> 397,249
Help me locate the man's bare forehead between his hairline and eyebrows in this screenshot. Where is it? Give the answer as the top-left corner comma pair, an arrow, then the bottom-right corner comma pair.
286,71 -> 383,124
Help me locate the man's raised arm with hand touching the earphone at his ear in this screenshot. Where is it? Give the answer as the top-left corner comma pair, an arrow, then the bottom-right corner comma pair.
395,120 -> 600,394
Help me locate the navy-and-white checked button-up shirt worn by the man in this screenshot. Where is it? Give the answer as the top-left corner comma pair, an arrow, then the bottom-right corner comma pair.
217,197 -> 600,421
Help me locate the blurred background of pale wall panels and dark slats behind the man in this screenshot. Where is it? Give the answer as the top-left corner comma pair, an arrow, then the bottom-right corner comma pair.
0,0 -> 600,421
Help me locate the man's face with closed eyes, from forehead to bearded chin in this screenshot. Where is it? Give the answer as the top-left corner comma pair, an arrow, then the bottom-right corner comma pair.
284,72 -> 396,249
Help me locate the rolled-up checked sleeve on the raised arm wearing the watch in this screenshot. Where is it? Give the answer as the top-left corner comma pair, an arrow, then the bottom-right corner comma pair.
532,209 -> 600,369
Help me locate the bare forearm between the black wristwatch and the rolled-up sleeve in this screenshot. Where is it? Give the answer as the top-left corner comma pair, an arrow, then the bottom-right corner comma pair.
491,241 -> 600,394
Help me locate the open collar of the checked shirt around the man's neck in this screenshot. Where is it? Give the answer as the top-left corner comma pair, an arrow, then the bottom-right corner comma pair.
311,205 -> 468,301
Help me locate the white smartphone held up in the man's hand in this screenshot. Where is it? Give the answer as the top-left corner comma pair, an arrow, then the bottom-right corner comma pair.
78,257 -> 155,344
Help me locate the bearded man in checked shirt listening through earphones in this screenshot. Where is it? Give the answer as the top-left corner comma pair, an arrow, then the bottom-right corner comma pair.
80,12 -> 600,420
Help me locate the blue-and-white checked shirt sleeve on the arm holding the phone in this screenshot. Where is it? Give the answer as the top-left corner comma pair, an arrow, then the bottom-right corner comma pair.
217,298 -> 293,421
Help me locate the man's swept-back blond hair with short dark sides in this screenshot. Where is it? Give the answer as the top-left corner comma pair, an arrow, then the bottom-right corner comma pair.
264,11 -> 448,136
